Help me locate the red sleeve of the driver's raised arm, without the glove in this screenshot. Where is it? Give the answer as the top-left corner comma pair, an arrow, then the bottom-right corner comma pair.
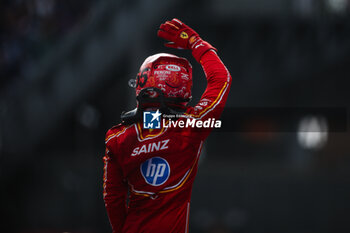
186,50 -> 232,138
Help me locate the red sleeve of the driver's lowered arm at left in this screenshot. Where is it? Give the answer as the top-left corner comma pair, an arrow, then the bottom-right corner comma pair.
103,147 -> 127,233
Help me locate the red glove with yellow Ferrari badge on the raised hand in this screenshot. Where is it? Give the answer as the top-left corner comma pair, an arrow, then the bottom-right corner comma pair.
158,19 -> 217,62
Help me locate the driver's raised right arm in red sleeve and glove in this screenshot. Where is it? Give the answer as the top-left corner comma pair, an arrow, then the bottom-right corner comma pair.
158,19 -> 232,137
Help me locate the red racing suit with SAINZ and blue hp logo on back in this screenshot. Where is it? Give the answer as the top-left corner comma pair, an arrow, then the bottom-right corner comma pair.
103,50 -> 231,233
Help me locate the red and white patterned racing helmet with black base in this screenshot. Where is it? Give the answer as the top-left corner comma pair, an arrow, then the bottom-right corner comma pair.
121,53 -> 192,124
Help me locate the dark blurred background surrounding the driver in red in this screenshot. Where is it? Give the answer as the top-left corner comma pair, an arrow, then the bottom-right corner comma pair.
0,0 -> 350,233
